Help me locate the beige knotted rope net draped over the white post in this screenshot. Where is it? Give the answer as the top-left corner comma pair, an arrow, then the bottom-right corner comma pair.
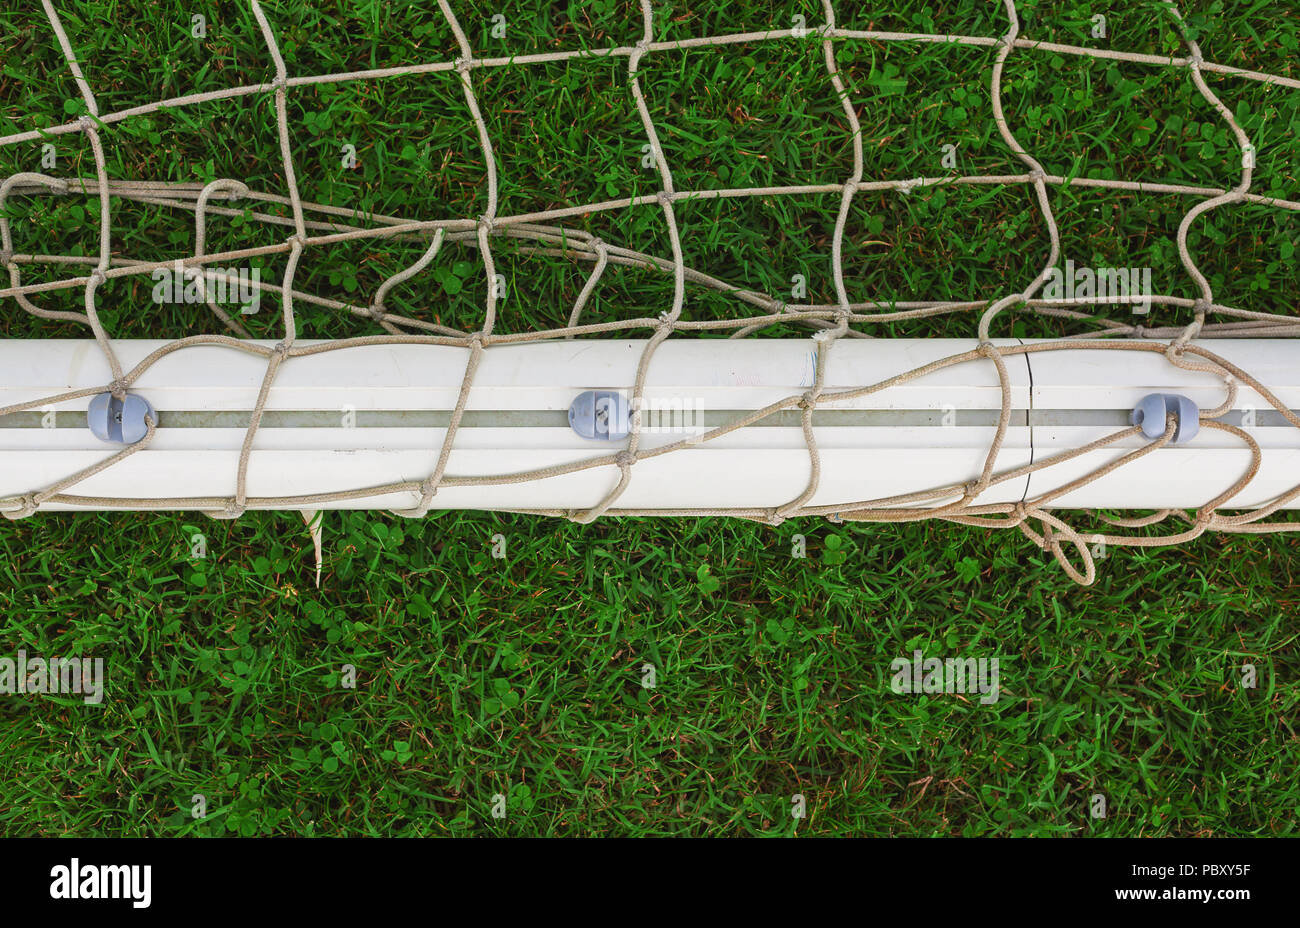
0,0 -> 1300,584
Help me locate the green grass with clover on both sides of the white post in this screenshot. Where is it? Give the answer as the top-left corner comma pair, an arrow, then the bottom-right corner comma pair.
0,0 -> 1300,836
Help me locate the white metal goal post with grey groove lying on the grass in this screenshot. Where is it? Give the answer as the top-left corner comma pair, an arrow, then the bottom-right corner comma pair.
0,338 -> 1300,515
